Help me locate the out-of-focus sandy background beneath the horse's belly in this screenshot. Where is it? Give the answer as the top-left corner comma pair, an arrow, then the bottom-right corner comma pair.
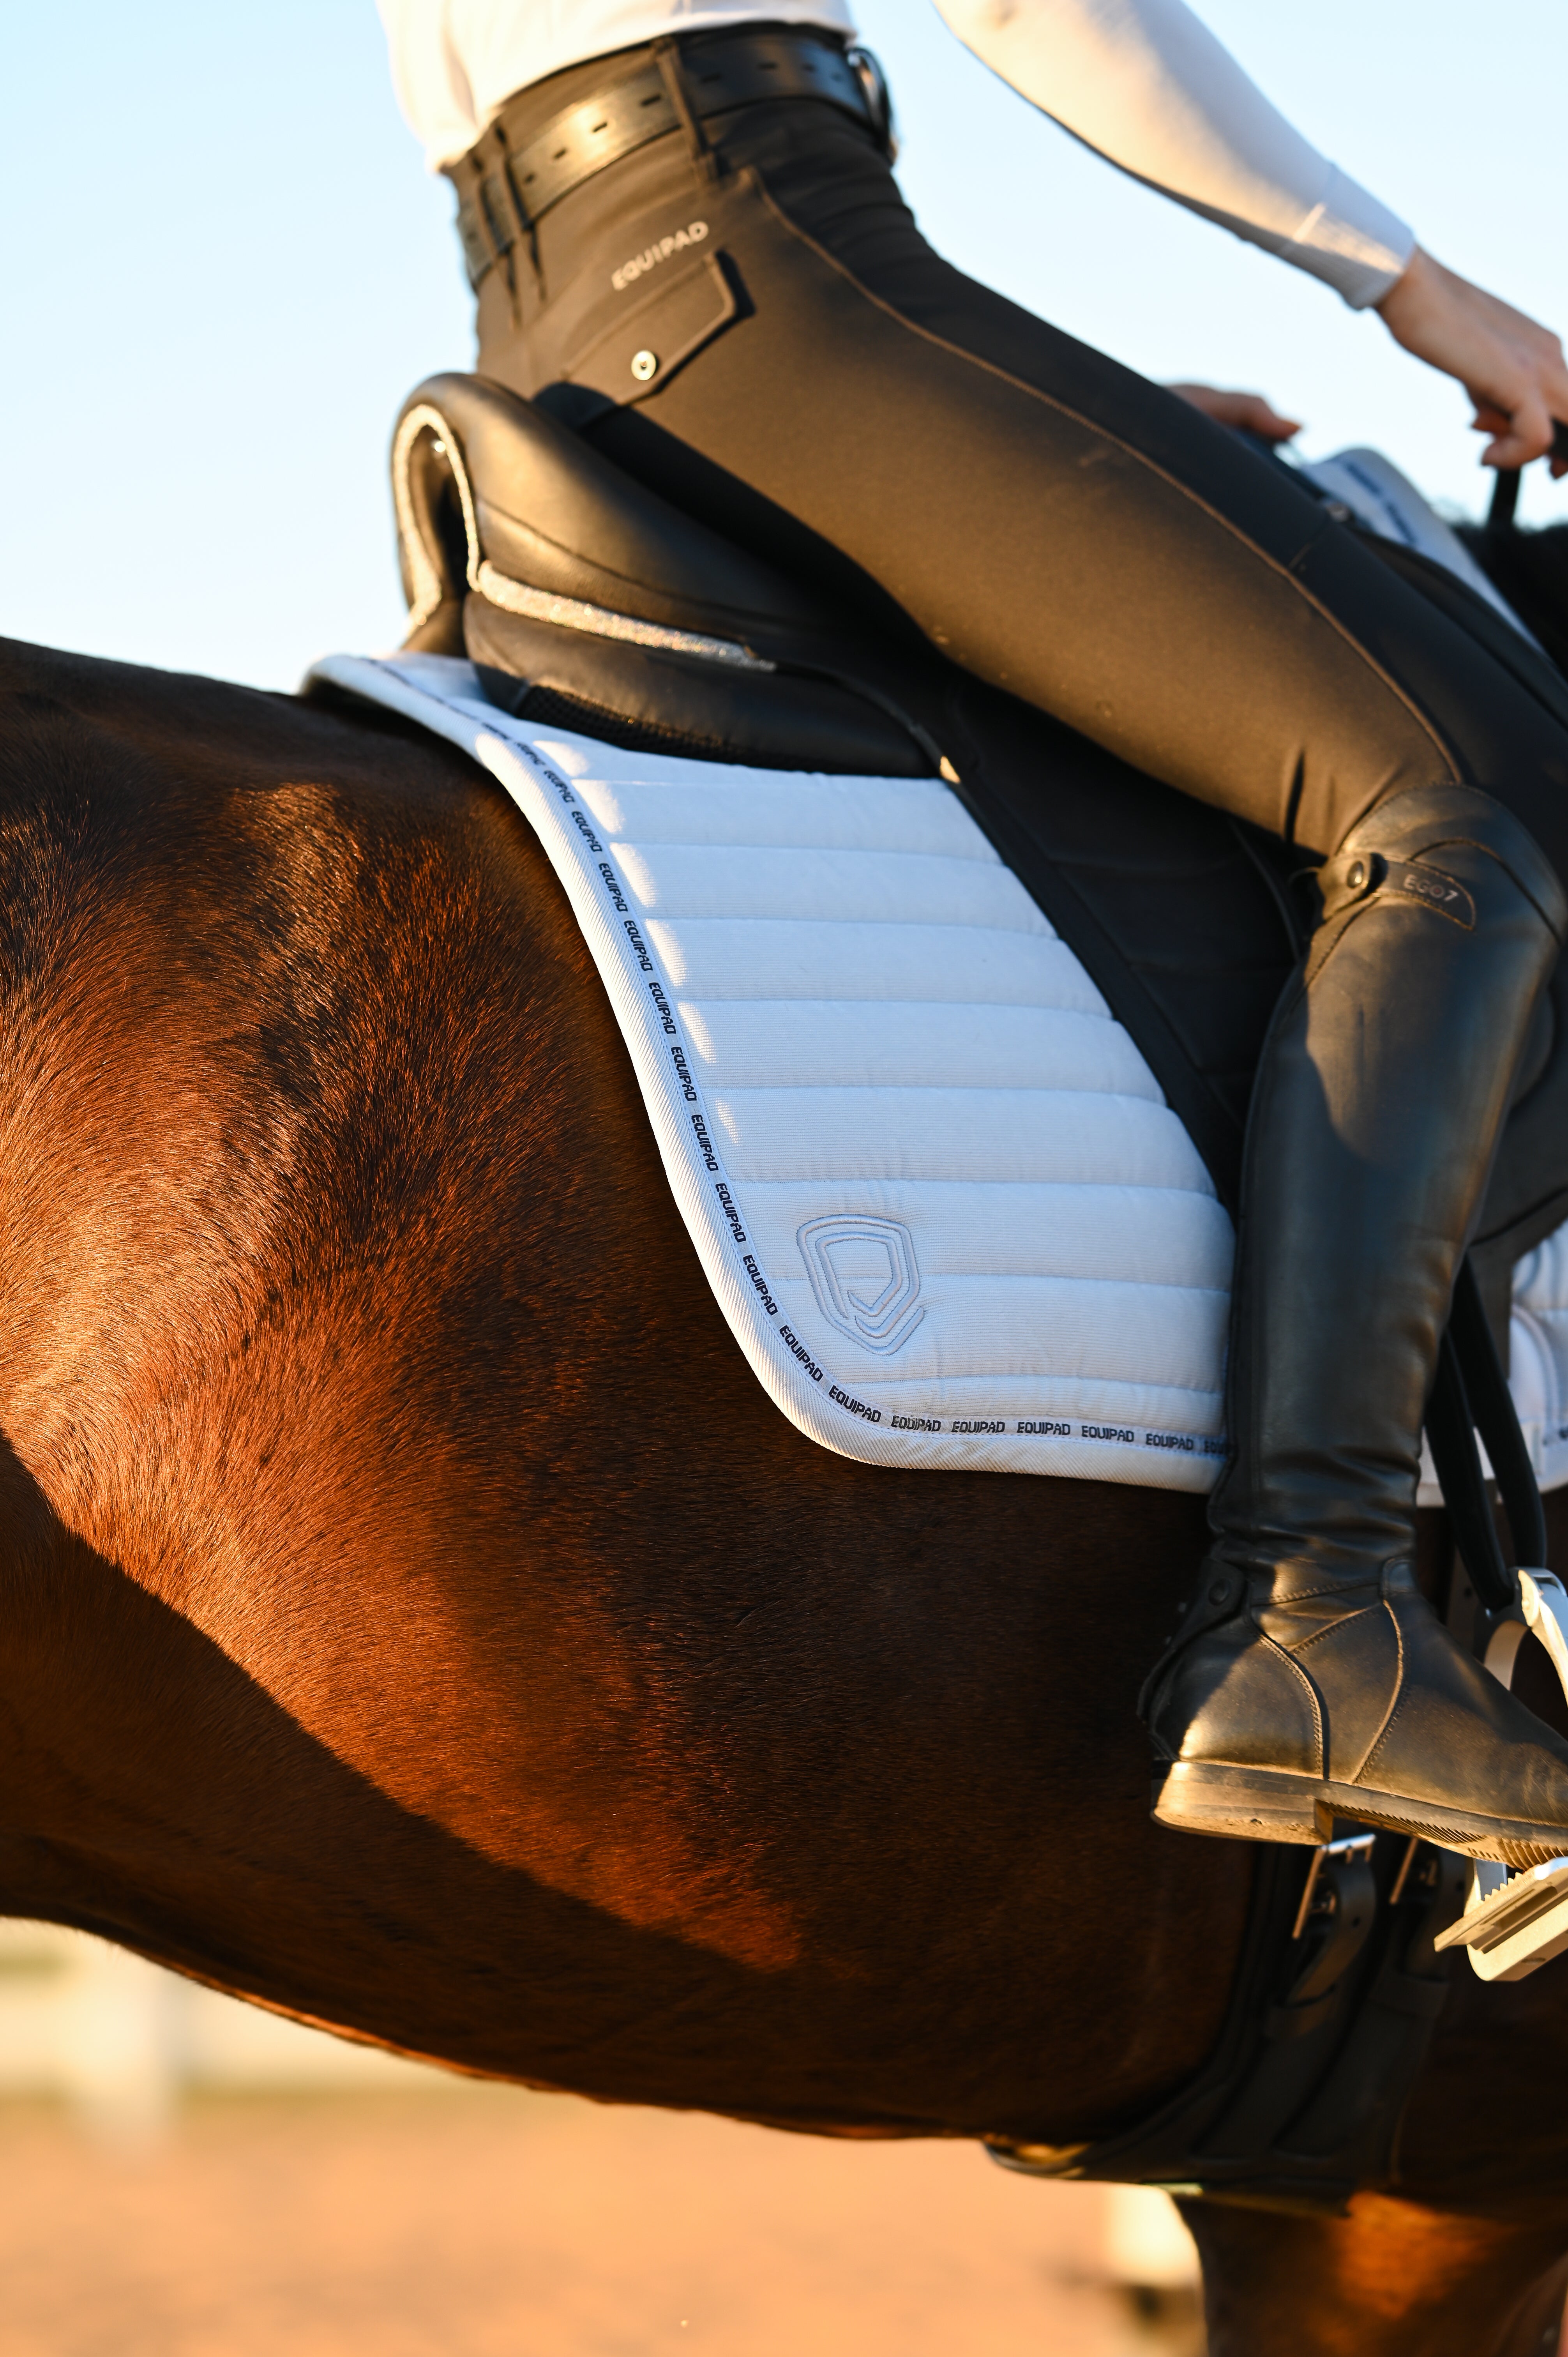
0,1928 -> 1198,2357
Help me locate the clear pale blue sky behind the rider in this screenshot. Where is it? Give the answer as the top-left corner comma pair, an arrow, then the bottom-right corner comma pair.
0,0 -> 1568,688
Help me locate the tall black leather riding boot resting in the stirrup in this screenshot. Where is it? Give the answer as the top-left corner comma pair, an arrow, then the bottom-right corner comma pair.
1144,785 -> 1568,1864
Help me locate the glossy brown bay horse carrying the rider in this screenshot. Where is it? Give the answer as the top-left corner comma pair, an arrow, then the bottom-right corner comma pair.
0,643 -> 1568,2357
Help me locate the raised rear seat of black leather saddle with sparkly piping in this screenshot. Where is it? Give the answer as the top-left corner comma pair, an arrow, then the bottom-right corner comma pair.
391,373 -> 941,778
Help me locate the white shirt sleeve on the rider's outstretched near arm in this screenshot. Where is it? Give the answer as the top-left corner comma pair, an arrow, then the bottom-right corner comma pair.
936,0 -> 1415,309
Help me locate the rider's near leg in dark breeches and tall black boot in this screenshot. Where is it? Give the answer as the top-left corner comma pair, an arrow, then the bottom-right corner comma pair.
452,60 -> 1568,1857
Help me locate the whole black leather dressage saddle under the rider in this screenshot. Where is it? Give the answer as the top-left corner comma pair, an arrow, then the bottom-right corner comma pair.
391,375 -> 1568,1310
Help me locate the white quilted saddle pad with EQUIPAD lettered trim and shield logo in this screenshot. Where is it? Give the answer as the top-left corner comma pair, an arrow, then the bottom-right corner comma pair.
314,655 -> 1568,1494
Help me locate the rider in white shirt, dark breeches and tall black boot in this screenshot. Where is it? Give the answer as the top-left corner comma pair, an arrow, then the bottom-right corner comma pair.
382,0 -> 1568,1864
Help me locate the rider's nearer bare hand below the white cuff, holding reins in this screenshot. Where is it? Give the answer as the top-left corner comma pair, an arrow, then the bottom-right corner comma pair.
1377,245 -> 1568,474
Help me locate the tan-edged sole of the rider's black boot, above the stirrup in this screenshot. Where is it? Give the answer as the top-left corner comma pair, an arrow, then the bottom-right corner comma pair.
1153,1761 -> 1568,1867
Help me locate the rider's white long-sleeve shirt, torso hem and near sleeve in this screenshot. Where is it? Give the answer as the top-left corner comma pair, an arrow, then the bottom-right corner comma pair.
377,0 -> 1415,309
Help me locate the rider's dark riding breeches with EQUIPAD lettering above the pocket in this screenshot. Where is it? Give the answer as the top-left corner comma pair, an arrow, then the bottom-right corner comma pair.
462,52 -> 1568,875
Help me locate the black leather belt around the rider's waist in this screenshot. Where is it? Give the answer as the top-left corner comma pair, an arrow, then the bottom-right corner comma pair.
453,26 -> 886,285
